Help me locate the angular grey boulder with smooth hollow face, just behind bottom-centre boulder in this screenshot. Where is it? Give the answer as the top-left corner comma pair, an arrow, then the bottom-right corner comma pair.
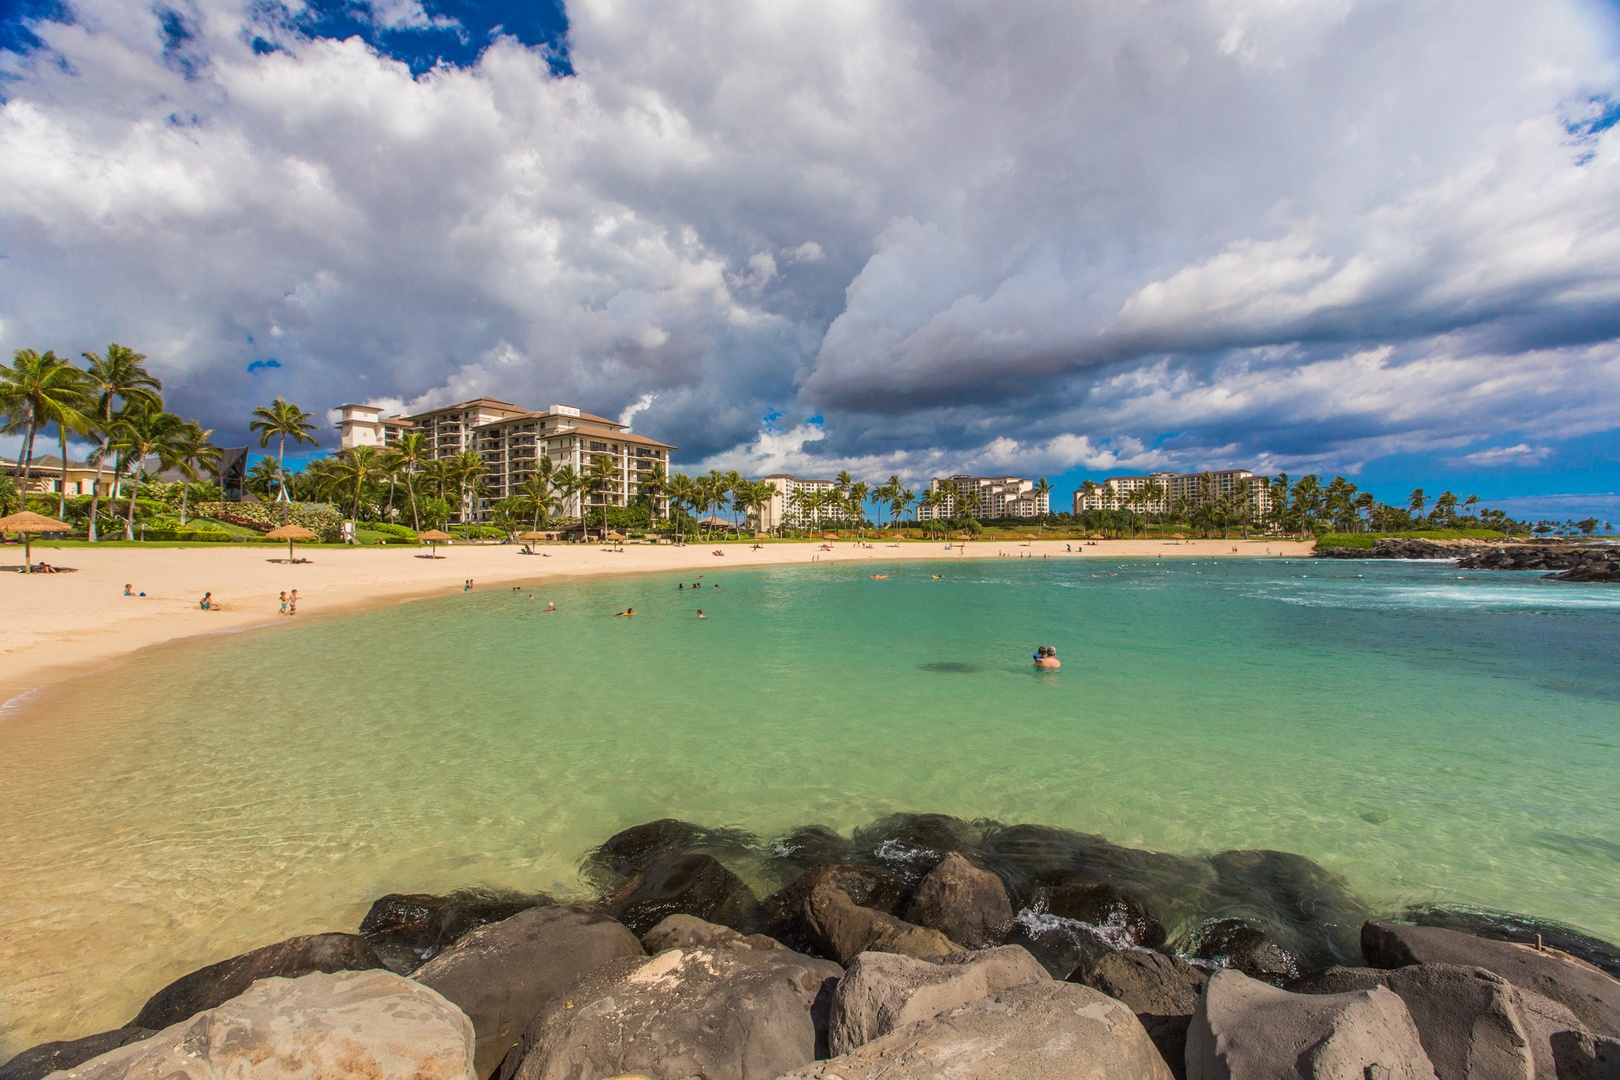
826,946 -> 1051,1054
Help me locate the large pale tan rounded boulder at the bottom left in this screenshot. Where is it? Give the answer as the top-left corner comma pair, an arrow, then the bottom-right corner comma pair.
53,972 -> 476,1080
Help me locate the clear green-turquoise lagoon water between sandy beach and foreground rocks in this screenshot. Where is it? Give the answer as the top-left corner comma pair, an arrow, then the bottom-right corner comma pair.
0,555 -> 1620,1052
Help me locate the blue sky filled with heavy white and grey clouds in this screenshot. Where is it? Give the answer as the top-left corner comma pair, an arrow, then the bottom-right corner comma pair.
0,0 -> 1620,518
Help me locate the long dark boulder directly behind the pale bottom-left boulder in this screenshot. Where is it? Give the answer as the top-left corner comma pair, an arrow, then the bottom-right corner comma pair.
125,934 -> 386,1031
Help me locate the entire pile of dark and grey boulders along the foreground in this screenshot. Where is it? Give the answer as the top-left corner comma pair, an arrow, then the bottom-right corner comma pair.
0,814 -> 1620,1080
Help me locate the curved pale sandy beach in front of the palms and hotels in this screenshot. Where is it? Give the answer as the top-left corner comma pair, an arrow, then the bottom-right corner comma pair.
0,538 -> 1312,701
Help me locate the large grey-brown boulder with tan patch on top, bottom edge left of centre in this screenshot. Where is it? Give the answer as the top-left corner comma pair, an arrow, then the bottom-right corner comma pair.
499,949 -> 842,1080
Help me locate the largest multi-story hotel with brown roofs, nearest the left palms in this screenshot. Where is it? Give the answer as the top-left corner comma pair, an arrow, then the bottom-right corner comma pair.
337,398 -> 676,521
